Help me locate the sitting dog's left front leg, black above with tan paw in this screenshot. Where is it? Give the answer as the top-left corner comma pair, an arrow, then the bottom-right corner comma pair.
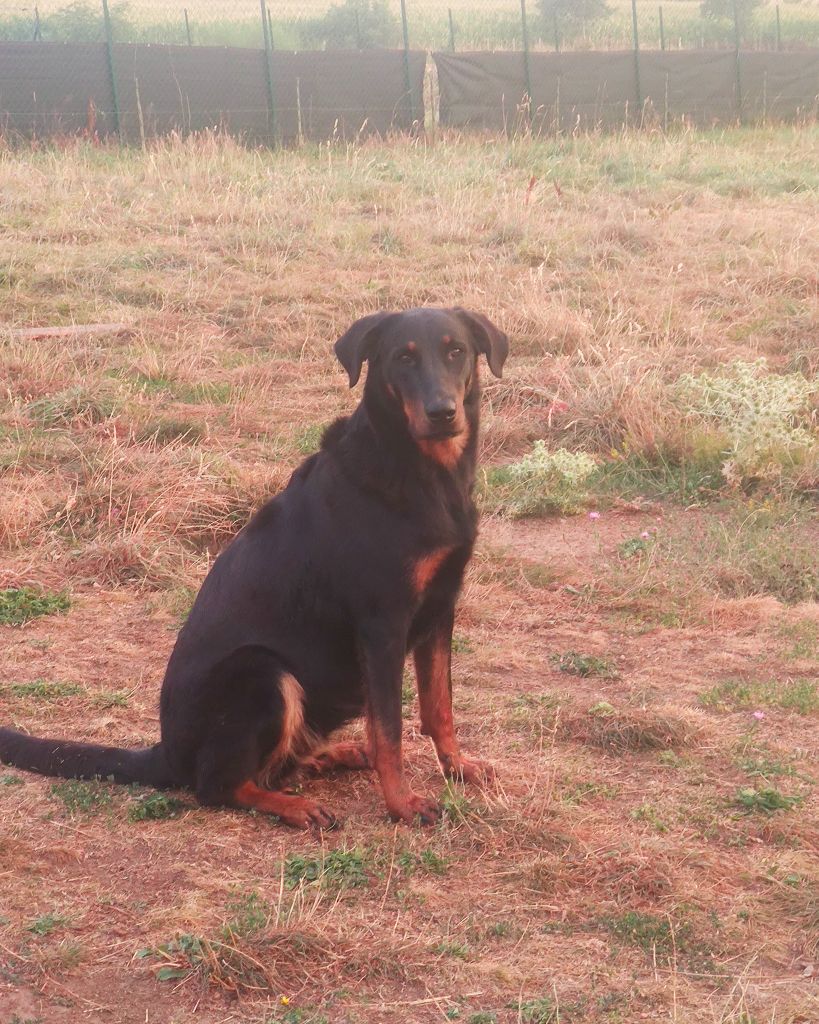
361,626 -> 441,824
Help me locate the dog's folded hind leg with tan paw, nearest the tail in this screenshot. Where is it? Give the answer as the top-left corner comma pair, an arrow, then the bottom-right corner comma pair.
196,648 -> 336,828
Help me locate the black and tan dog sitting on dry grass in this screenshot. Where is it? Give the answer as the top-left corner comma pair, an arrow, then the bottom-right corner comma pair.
0,308 -> 509,827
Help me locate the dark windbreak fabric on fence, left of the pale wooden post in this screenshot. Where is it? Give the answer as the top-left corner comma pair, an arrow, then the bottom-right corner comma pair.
0,42 -> 426,141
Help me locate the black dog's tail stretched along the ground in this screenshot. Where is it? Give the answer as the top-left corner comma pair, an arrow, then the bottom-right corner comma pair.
0,729 -> 176,790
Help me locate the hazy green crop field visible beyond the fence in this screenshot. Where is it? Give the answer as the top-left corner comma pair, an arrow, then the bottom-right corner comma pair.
0,0 -> 819,49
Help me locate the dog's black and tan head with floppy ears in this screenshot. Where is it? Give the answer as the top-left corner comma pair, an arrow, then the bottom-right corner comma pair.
336,307 -> 509,442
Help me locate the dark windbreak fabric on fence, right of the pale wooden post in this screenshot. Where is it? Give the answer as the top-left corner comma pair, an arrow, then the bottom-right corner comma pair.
434,50 -> 819,130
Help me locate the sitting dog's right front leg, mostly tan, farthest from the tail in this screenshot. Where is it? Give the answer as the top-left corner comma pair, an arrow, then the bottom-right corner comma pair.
413,608 -> 494,784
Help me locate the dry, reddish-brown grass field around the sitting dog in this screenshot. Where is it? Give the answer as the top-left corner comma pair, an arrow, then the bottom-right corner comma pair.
0,126 -> 819,1024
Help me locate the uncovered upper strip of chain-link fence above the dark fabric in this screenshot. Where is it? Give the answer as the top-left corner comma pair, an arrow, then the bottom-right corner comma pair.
0,0 -> 819,51
